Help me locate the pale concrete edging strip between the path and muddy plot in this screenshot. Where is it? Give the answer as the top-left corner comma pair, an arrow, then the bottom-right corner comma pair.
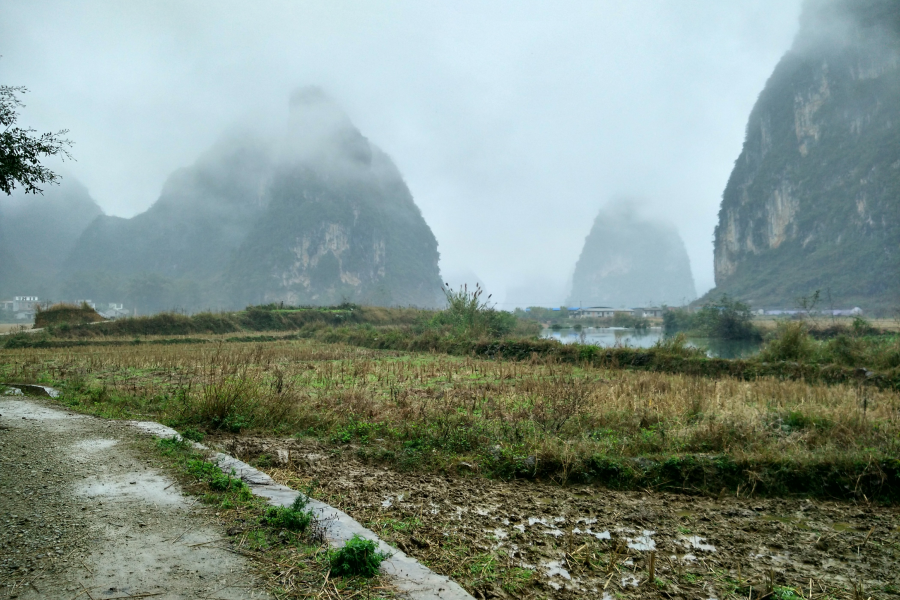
128,421 -> 474,600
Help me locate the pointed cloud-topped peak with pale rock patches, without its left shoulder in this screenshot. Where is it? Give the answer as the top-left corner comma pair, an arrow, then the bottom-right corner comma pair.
226,88 -> 441,306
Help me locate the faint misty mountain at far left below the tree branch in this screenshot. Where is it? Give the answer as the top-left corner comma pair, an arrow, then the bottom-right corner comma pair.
0,176 -> 103,296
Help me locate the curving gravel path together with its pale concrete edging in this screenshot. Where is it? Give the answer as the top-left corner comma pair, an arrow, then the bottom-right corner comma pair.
0,384 -> 473,600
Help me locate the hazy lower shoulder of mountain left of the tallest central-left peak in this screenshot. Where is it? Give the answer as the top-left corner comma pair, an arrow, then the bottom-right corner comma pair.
66,135 -> 270,280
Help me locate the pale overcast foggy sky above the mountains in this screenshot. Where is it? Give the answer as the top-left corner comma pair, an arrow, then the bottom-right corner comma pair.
0,0 -> 800,307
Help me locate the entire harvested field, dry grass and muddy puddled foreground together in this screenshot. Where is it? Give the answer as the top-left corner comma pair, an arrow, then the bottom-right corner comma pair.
0,336 -> 900,599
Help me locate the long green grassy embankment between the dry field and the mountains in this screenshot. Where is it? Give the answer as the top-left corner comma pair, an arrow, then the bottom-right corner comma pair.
3,293 -> 900,390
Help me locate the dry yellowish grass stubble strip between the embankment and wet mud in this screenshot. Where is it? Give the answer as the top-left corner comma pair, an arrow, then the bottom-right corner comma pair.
0,341 -> 900,476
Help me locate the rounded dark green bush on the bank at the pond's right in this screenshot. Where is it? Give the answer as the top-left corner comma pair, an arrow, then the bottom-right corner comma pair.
663,295 -> 761,340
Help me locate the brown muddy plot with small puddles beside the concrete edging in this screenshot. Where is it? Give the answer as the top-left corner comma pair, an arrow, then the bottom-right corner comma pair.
217,438 -> 900,599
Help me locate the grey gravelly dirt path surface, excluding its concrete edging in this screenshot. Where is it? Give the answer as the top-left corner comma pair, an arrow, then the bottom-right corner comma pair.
0,397 -> 269,600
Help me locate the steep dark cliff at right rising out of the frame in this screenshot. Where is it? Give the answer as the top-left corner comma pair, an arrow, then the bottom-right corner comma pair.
711,0 -> 900,311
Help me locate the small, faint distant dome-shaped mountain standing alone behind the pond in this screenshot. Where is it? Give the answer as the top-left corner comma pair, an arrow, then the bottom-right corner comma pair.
566,204 -> 697,307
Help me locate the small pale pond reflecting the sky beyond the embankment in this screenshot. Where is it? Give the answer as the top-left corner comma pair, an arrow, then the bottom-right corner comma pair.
541,327 -> 760,358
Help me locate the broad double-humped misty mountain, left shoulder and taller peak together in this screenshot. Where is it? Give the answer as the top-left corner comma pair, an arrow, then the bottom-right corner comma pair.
66,88 -> 441,311
